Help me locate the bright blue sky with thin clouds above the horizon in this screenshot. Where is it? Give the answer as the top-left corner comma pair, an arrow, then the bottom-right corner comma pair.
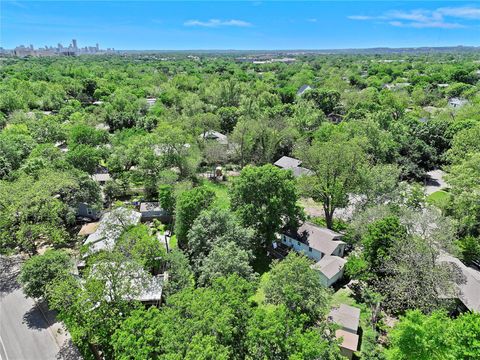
0,0 -> 480,50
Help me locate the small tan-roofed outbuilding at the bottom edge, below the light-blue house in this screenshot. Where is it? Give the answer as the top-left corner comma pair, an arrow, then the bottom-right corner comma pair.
328,304 -> 360,359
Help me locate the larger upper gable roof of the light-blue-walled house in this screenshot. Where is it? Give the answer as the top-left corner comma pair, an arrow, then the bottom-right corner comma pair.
284,222 -> 345,255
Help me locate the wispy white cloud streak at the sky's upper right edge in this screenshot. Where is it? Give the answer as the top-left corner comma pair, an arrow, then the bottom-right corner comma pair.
348,6 -> 480,29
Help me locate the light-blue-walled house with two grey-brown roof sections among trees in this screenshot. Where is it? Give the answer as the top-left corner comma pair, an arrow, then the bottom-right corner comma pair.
280,222 -> 346,287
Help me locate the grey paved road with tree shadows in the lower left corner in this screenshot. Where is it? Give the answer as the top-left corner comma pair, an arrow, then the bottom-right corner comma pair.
0,257 -> 80,360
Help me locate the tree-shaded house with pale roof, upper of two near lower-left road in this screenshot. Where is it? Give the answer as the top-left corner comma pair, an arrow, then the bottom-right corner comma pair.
84,207 -> 141,256
